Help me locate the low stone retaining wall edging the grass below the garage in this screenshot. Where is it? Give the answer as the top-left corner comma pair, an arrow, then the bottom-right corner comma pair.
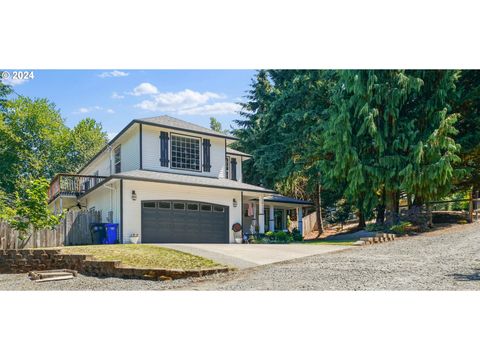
0,249 -> 229,280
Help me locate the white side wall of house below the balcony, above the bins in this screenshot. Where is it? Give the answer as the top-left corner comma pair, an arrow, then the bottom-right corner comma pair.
81,180 -> 120,224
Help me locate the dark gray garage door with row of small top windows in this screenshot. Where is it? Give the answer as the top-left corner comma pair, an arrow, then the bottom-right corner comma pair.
141,200 -> 228,243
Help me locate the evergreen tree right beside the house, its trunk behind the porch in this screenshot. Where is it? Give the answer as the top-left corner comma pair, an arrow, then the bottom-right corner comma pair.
237,70 -> 336,233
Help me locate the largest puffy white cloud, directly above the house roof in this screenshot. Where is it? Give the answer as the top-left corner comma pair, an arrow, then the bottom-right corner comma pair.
135,89 -> 224,113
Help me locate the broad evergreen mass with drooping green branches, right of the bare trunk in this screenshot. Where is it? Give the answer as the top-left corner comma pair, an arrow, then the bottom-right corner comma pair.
325,70 -> 458,222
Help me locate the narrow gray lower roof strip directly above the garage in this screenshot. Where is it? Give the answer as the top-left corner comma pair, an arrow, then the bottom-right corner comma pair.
112,170 -> 275,194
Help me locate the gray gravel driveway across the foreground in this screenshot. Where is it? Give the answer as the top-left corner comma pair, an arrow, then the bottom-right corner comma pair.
0,223 -> 480,290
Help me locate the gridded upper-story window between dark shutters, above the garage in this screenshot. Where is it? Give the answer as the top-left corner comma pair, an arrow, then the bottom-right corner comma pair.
171,134 -> 200,171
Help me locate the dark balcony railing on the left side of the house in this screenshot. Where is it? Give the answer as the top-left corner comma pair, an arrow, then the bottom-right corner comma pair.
48,174 -> 106,201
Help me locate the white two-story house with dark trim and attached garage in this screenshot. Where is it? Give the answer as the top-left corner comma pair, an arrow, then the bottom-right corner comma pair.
49,116 -> 311,243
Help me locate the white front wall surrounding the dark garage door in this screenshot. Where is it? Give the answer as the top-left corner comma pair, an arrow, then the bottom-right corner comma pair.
123,180 -> 242,243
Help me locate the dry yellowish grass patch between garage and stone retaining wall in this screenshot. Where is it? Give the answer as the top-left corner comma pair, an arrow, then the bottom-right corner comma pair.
61,244 -> 223,270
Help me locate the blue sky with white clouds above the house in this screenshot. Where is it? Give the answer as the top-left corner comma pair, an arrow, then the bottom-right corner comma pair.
4,69 -> 255,137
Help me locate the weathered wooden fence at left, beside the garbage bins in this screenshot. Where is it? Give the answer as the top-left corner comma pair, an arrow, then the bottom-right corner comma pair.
0,211 -> 102,249
